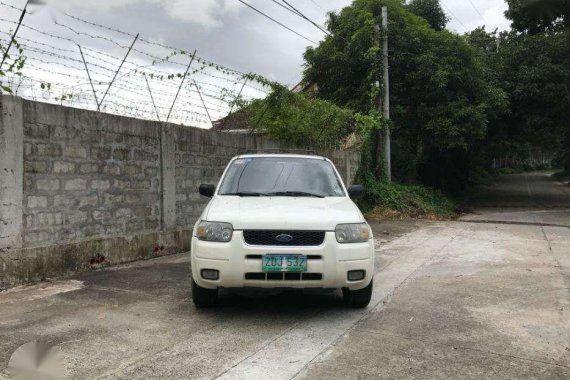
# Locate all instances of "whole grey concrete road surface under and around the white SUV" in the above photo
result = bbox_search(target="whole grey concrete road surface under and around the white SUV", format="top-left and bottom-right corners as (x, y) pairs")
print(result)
(0, 174), (570, 379)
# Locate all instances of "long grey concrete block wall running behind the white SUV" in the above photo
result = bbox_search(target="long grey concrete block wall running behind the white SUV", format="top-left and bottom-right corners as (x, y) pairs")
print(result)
(0, 96), (359, 289)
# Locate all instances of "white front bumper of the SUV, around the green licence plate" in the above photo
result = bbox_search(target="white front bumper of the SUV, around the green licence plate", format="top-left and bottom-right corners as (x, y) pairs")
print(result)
(191, 231), (374, 290)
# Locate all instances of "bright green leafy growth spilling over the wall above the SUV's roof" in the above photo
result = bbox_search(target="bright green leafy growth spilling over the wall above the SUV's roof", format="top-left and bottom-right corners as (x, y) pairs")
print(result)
(241, 84), (378, 146)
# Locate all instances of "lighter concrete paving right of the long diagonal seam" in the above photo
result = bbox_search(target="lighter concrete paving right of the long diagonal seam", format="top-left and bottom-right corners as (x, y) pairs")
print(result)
(300, 224), (570, 379)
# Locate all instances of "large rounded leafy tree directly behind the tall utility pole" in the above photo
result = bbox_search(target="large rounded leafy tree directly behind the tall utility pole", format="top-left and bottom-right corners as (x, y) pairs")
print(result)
(304, 0), (506, 190)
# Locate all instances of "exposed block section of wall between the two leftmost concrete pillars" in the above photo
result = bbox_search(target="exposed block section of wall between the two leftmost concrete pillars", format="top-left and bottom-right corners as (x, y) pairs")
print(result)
(22, 101), (161, 246)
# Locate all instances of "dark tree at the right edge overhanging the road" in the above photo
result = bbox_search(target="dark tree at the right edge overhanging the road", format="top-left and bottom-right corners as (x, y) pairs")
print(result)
(467, 0), (570, 168)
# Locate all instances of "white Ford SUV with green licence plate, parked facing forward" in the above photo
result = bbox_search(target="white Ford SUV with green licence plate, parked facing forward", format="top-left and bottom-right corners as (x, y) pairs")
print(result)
(191, 154), (374, 308)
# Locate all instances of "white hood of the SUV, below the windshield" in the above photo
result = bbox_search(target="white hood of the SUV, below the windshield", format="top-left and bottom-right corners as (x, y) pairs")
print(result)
(203, 196), (364, 231)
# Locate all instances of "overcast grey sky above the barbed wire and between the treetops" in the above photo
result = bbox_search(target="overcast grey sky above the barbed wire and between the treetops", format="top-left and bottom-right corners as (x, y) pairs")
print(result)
(4, 0), (509, 84)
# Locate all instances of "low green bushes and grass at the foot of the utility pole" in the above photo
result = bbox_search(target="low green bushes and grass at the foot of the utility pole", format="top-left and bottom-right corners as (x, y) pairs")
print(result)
(360, 181), (457, 220)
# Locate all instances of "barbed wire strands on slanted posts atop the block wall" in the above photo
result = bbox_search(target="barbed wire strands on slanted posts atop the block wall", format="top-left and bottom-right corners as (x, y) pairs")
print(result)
(0, 1), (270, 125)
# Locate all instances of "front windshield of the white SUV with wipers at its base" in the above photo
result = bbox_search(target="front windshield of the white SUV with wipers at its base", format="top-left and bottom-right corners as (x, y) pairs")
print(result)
(218, 157), (345, 197)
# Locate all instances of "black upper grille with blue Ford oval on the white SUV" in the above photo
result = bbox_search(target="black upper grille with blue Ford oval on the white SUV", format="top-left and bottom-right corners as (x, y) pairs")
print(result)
(243, 230), (325, 247)
